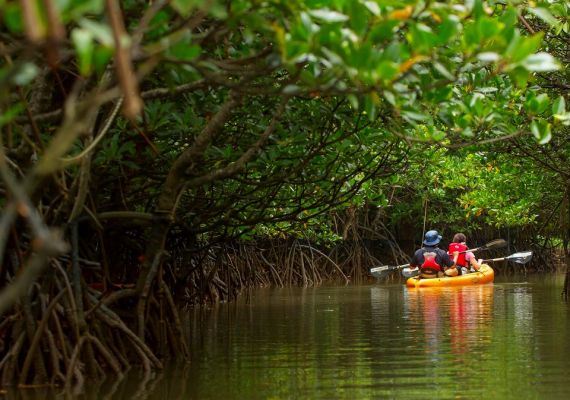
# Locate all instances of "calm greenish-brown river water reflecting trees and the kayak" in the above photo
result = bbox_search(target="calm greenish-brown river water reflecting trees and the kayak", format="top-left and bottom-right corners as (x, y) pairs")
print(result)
(6, 275), (570, 400)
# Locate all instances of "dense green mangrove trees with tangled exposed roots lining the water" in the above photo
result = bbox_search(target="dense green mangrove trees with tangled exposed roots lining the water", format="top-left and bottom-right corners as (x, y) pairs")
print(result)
(0, 0), (570, 388)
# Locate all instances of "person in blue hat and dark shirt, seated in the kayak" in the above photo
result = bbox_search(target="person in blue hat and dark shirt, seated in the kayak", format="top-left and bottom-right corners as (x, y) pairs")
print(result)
(410, 230), (459, 278)
